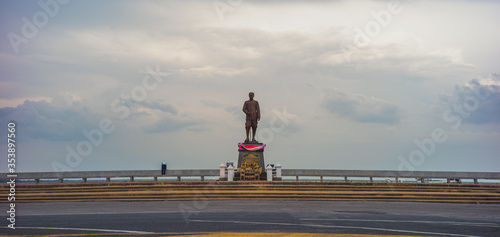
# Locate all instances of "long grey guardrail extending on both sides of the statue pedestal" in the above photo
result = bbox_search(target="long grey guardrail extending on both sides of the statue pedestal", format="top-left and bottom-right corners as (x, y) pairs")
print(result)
(0, 169), (500, 183)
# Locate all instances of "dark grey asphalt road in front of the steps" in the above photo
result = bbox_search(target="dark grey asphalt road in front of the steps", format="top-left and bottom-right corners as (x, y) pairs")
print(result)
(0, 199), (500, 236)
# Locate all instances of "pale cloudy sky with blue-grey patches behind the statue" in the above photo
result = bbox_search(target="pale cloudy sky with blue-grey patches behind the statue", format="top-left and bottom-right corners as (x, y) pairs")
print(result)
(0, 0), (500, 172)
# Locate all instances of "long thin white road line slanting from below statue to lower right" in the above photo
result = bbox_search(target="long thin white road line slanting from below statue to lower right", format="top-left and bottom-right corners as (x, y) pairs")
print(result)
(190, 220), (479, 237)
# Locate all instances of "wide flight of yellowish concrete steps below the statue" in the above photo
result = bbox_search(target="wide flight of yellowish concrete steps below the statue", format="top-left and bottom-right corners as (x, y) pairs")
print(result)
(0, 182), (500, 203)
